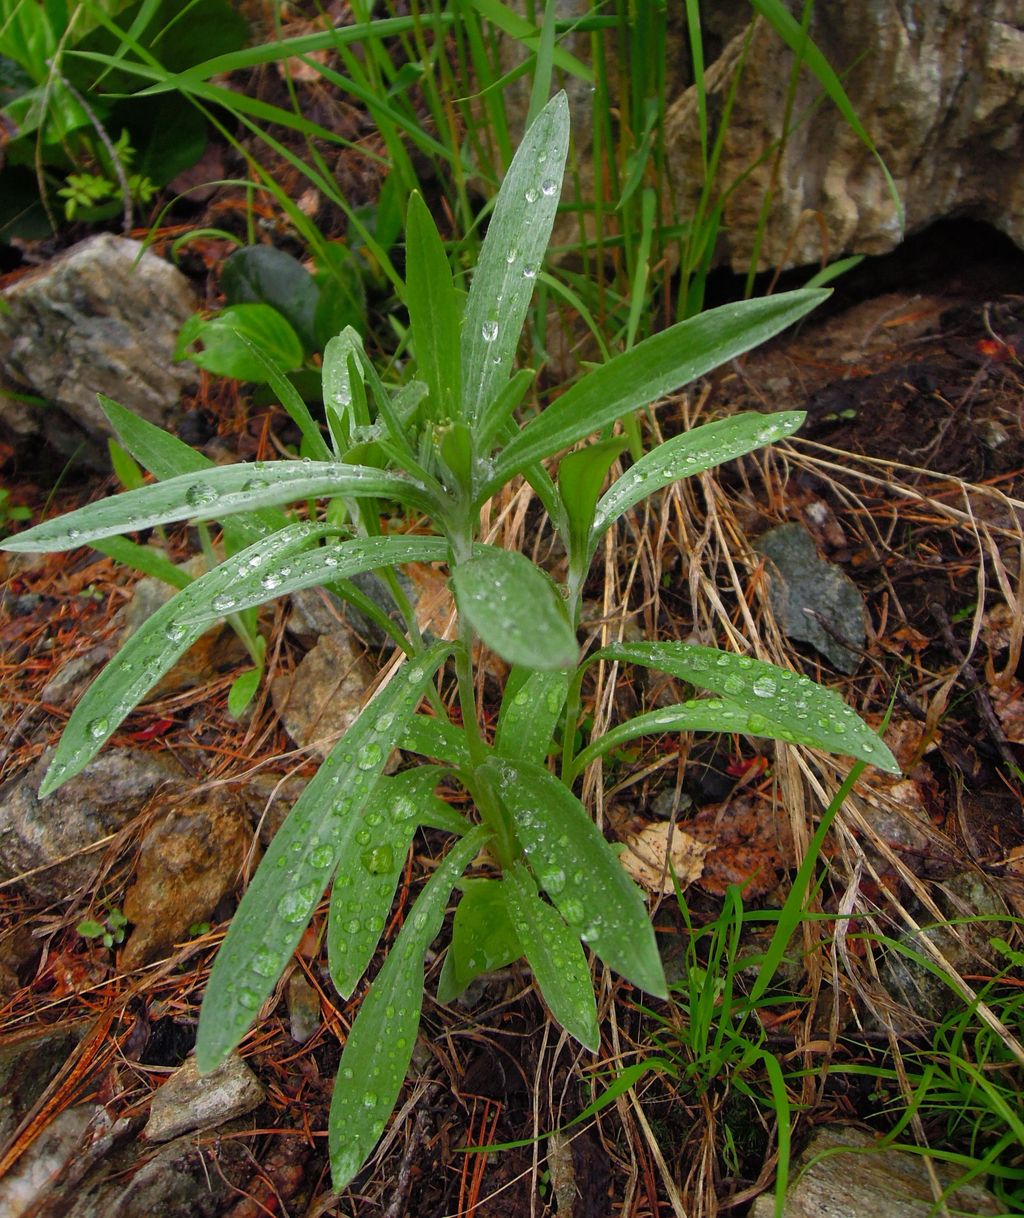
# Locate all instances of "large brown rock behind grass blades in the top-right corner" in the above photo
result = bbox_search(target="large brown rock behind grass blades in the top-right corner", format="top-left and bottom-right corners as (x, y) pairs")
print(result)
(664, 0), (1024, 272)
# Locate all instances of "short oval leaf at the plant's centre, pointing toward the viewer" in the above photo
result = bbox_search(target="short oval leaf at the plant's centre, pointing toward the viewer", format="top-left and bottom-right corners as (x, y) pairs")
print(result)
(450, 548), (580, 670)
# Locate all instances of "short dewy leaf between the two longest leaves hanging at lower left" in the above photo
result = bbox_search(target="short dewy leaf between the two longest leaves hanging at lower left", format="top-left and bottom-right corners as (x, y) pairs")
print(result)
(328, 766), (443, 998)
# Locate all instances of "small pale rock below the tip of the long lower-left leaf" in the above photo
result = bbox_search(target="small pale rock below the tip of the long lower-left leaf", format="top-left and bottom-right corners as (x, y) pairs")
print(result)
(142, 1054), (263, 1142)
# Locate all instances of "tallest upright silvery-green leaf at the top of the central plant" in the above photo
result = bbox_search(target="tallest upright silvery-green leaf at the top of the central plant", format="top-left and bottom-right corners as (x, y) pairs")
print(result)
(461, 93), (569, 429)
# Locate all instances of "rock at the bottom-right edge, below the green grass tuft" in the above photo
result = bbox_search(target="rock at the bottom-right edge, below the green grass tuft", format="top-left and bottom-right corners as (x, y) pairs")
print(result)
(750, 1125), (1002, 1218)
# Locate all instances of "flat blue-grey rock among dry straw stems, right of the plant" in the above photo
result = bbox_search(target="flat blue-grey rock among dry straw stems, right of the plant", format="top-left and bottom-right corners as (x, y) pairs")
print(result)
(756, 524), (866, 672)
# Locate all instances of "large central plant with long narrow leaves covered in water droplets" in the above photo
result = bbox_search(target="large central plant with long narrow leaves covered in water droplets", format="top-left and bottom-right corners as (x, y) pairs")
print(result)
(6, 94), (897, 1188)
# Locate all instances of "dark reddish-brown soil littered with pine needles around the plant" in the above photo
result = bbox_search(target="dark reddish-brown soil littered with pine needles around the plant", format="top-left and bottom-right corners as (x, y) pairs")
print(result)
(0, 190), (1024, 1218)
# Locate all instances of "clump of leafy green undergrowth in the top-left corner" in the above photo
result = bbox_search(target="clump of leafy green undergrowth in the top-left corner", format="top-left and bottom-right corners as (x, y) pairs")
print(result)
(0, 0), (248, 239)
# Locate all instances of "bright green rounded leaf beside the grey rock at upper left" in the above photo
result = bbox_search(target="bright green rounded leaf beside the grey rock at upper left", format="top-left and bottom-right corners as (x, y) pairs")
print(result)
(174, 305), (302, 381)
